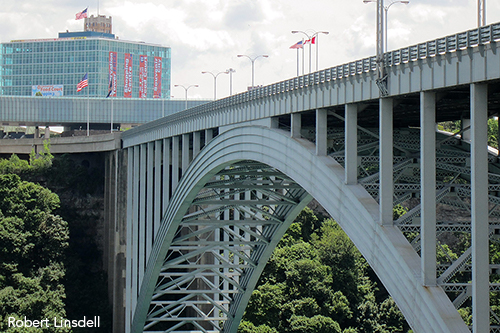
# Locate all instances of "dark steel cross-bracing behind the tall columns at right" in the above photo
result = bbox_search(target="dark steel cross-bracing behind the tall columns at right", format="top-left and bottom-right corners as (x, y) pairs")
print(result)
(330, 125), (500, 332)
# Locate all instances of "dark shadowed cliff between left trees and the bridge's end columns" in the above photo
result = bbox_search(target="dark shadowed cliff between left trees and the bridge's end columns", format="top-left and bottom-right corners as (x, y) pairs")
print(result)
(40, 154), (112, 332)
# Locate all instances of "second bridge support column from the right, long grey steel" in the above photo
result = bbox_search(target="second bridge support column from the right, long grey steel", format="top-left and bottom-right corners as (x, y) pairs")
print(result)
(420, 92), (436, 286)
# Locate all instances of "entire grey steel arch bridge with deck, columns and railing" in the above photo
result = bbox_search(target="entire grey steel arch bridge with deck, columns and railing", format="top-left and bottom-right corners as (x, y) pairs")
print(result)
(122, 24), (500, 333)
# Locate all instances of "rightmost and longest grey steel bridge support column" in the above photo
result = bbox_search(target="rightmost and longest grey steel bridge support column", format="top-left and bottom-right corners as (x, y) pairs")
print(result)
(470, 84), (490, 333)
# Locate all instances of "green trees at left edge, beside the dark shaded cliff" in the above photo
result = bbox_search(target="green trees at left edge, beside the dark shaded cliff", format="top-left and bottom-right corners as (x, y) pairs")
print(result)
(0, 174), (71, 332)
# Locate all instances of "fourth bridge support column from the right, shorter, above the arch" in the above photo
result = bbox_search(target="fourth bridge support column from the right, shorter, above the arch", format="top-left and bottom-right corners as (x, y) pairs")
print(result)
(344, 104), (358, 185)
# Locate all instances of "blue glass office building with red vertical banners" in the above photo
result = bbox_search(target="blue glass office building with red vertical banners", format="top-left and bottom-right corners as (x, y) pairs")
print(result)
(0, 31), (171, 99)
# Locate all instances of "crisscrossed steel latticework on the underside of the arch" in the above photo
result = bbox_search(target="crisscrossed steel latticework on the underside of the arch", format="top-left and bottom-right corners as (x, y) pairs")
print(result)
(144, 161), (309, 333)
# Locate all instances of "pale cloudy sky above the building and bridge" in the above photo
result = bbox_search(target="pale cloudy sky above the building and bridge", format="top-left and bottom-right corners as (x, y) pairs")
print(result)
(0, 0), (500, 99)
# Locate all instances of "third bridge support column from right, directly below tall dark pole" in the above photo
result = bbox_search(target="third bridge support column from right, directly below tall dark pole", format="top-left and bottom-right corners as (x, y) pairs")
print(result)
(379, 98), (394, 225)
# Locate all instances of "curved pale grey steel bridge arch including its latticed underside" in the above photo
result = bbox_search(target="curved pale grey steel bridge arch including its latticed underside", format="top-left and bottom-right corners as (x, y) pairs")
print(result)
(132, 126), (469, 333)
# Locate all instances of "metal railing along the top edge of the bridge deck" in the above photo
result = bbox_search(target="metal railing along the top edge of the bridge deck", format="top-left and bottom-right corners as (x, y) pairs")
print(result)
(124, 23), (500, 137)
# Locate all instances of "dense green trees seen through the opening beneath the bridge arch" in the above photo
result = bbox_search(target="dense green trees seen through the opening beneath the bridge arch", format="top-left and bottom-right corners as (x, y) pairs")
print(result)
(238, 207), (408, 333)
